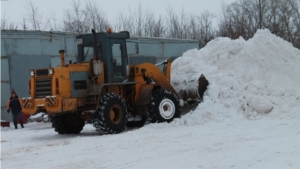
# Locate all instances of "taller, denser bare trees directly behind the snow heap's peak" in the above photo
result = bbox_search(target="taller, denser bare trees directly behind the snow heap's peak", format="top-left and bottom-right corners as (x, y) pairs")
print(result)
(218, 0), (300, 47)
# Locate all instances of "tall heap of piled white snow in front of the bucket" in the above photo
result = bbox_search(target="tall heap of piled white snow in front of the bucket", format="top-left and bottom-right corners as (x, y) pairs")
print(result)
(171, 30), (300, 125)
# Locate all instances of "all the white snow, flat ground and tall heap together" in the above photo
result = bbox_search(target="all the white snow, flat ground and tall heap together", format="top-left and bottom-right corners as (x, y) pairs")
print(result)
(1, 30), (300, 169)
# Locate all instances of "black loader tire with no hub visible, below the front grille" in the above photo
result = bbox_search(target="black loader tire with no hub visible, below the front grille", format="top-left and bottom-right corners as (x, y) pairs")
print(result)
(52, 113), (85, 134)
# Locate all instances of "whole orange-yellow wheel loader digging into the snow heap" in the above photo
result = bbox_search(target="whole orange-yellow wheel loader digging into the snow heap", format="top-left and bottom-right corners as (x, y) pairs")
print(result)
(22, 30), (208, 134)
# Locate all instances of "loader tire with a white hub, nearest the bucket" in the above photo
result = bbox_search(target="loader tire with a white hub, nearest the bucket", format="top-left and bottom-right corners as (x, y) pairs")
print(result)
(148, 89), (180, 123)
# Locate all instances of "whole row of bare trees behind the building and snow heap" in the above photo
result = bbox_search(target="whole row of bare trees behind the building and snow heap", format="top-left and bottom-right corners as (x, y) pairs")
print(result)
(1, 0), (300, 48)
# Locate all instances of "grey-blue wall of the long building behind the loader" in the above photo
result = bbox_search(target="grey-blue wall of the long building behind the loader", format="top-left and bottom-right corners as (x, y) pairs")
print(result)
(1, 30), (199, 121)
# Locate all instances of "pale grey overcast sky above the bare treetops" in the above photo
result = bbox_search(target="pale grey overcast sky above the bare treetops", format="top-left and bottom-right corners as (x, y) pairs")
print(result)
(1, 0), (235, 27)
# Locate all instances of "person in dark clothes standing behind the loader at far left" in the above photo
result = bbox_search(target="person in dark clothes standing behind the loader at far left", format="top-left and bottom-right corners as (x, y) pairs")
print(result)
(6, 92), (24, 129)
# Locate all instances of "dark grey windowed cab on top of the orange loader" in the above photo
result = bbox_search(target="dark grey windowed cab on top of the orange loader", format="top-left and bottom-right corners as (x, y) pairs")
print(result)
(76, 31), (129, 83)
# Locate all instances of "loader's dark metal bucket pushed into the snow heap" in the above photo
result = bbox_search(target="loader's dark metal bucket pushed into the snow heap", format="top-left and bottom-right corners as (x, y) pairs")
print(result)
(175, 74), (209, 106)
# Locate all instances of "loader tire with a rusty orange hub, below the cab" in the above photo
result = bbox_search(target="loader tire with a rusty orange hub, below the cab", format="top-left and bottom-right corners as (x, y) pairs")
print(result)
(93, 93), (127, 135)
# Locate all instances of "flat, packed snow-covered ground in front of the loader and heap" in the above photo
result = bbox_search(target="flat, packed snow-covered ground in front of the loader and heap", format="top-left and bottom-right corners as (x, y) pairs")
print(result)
(1, 118), (300, 169)
